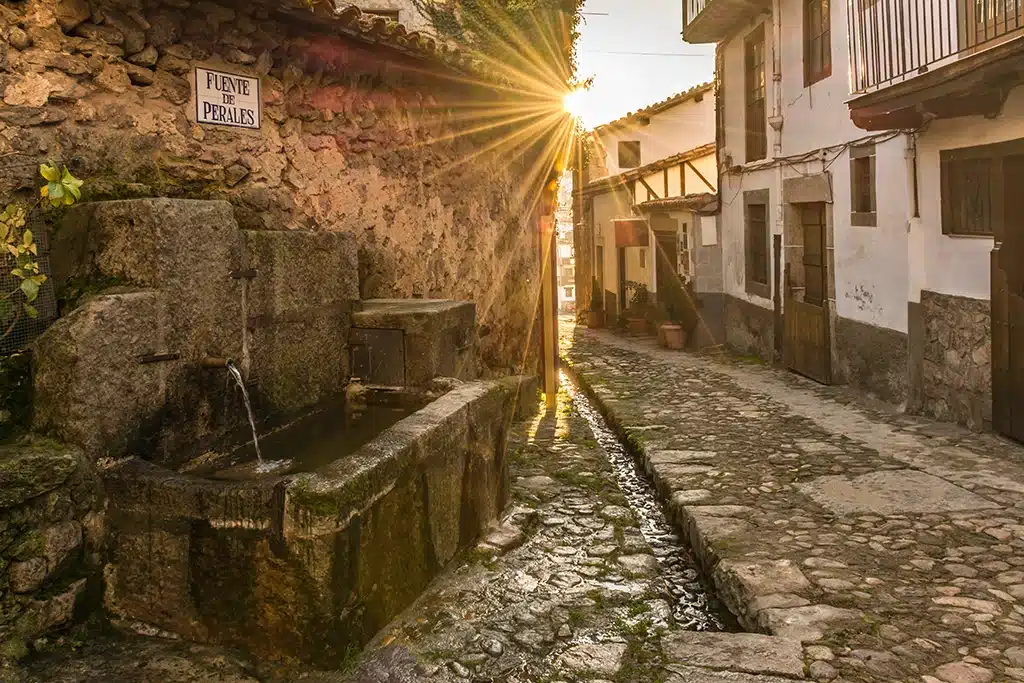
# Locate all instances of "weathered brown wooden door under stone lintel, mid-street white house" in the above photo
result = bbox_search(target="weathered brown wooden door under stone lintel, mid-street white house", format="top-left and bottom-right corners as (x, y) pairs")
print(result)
(782, 202), (831, 384)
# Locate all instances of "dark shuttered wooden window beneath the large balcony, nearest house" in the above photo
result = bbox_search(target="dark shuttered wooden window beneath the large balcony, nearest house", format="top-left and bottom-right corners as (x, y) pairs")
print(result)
(941, 157), (998, 236)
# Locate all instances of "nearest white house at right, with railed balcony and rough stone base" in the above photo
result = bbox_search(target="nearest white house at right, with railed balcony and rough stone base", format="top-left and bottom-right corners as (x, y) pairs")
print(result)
(847, 0), (1024, 440)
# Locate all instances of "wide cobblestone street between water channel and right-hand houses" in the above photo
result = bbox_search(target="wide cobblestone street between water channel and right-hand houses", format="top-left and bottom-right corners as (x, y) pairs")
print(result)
(562, 326), (1024, 683)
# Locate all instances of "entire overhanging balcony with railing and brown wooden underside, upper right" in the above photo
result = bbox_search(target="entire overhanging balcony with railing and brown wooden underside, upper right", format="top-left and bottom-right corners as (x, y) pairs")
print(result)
(847, 0), (1024, 130)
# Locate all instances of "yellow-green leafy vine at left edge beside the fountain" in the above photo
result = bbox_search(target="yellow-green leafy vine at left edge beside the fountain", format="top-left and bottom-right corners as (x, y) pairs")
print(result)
(0, 164), (82, 338)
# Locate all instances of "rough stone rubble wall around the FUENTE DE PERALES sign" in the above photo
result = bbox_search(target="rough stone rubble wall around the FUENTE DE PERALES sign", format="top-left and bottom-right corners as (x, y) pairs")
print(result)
(0, 0), (539, 374)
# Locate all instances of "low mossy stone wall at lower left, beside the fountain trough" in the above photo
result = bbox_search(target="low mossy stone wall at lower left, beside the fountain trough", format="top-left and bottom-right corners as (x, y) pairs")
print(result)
(0, 439), (103, 663)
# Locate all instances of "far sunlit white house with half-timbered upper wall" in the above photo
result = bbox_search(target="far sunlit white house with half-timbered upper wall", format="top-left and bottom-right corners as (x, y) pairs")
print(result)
(574, 84), (722, 342)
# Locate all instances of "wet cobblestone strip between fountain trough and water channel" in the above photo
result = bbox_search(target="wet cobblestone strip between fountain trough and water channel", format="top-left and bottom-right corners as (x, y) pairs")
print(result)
(339, 392), (716, 683)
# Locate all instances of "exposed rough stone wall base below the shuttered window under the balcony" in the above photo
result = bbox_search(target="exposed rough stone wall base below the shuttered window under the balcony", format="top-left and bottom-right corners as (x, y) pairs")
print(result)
(911, 291), (992, 430)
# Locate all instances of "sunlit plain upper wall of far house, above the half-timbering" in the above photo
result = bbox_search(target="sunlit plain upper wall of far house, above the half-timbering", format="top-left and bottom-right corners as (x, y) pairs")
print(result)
(591, 91), (715, 180)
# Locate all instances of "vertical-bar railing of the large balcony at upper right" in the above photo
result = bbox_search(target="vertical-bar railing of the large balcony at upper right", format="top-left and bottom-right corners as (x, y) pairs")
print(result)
(847, 0), (1024, 93)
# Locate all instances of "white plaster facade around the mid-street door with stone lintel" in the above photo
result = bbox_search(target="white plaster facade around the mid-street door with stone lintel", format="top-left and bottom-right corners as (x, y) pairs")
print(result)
(716, 0), (910, 332)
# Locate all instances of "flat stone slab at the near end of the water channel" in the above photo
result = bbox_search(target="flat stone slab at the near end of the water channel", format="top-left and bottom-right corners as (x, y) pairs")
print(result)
(662, 632), (804, 678)
